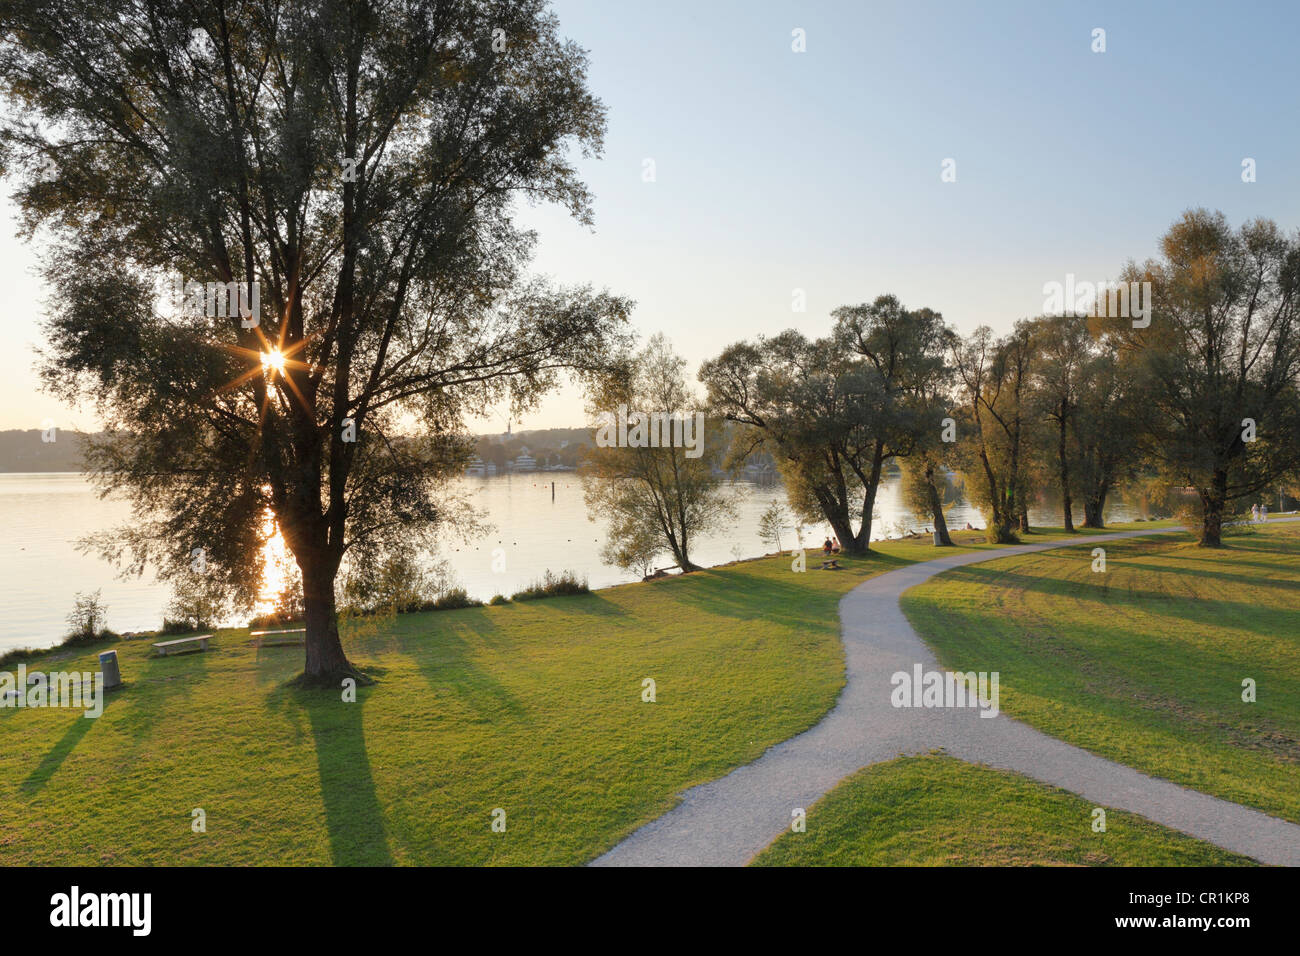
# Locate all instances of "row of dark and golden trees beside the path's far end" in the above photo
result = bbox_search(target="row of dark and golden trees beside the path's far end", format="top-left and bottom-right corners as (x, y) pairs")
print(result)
(699, 209), (1300, 554)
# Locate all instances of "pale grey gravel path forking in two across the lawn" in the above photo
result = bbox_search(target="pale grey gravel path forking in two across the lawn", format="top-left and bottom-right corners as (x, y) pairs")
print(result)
(593, 529), (1300, 866)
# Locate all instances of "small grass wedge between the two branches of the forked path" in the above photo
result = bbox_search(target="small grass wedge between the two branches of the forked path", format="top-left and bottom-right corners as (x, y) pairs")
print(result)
(753, 753), (1255, 866)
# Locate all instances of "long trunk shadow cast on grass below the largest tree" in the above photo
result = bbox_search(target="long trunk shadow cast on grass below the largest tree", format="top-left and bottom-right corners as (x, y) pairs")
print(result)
(276, 687), (393, 866)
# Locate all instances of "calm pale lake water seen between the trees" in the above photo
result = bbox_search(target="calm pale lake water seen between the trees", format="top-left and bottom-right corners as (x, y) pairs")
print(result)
(0, 472), (1132, 652)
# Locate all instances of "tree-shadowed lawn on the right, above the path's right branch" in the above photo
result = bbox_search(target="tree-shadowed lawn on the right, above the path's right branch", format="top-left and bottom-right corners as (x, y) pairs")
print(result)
(902, 524), (1300, 822)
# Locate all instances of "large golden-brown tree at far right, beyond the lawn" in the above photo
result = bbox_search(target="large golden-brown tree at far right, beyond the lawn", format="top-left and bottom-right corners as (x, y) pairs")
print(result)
(1109, 209), (1300, 548)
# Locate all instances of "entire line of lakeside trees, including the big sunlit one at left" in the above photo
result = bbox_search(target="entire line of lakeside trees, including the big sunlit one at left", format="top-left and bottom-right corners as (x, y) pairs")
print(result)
(0, 0), (1300, 687)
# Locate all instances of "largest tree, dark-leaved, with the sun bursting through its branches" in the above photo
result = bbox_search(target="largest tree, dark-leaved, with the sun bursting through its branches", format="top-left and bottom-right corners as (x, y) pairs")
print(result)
(0, 0), (629, 683)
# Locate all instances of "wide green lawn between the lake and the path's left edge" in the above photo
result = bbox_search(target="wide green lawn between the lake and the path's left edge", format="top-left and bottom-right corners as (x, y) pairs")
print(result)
(0, 525), (1206, 865)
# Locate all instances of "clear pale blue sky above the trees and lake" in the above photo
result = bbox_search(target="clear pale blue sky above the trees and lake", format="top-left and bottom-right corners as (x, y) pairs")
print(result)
(0, 0), (1300, 431)
